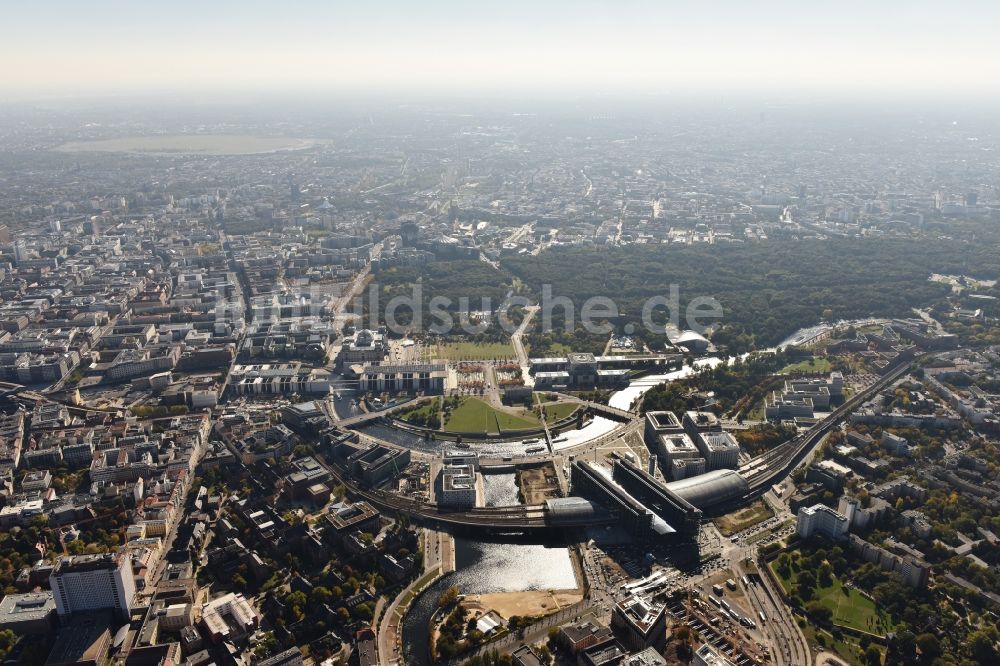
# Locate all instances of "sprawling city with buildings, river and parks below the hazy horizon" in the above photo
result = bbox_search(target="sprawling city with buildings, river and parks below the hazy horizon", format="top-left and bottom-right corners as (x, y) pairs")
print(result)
(0, 1), (1000, 666)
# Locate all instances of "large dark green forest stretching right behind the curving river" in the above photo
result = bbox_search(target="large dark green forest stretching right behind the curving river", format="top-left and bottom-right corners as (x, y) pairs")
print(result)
(505, 238), (1000, 352)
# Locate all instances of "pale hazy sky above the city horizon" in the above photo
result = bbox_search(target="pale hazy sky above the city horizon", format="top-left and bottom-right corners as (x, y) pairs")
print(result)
(7, 0), (1000, 98)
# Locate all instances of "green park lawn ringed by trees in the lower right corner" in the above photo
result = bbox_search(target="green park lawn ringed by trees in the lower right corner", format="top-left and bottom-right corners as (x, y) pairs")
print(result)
(770, 553), (893, 636)
